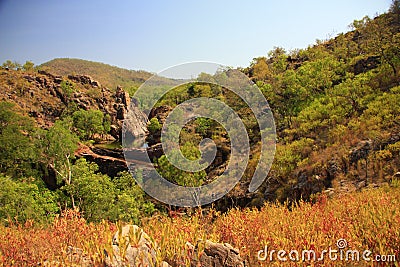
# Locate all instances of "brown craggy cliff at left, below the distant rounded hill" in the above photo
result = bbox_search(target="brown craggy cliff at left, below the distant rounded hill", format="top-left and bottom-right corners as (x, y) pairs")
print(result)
(0, 69), (147, 141)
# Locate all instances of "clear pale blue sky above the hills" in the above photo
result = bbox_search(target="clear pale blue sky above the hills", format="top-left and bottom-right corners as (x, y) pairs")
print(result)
(0, 0), (391, 72)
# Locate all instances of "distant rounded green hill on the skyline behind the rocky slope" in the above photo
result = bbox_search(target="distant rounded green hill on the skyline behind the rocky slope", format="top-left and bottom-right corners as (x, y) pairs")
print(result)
(40, 58), (152, 91)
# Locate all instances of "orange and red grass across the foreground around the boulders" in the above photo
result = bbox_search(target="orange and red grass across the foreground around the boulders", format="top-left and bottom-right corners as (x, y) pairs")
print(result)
(0, 186), (400, 266)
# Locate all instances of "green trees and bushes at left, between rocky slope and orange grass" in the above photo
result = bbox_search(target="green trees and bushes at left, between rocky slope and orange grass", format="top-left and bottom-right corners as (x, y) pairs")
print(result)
(0, 102), (154, 223)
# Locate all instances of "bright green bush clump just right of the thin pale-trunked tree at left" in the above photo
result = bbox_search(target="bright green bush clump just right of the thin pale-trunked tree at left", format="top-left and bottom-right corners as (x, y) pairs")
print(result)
(61, 158), (155, 223)
